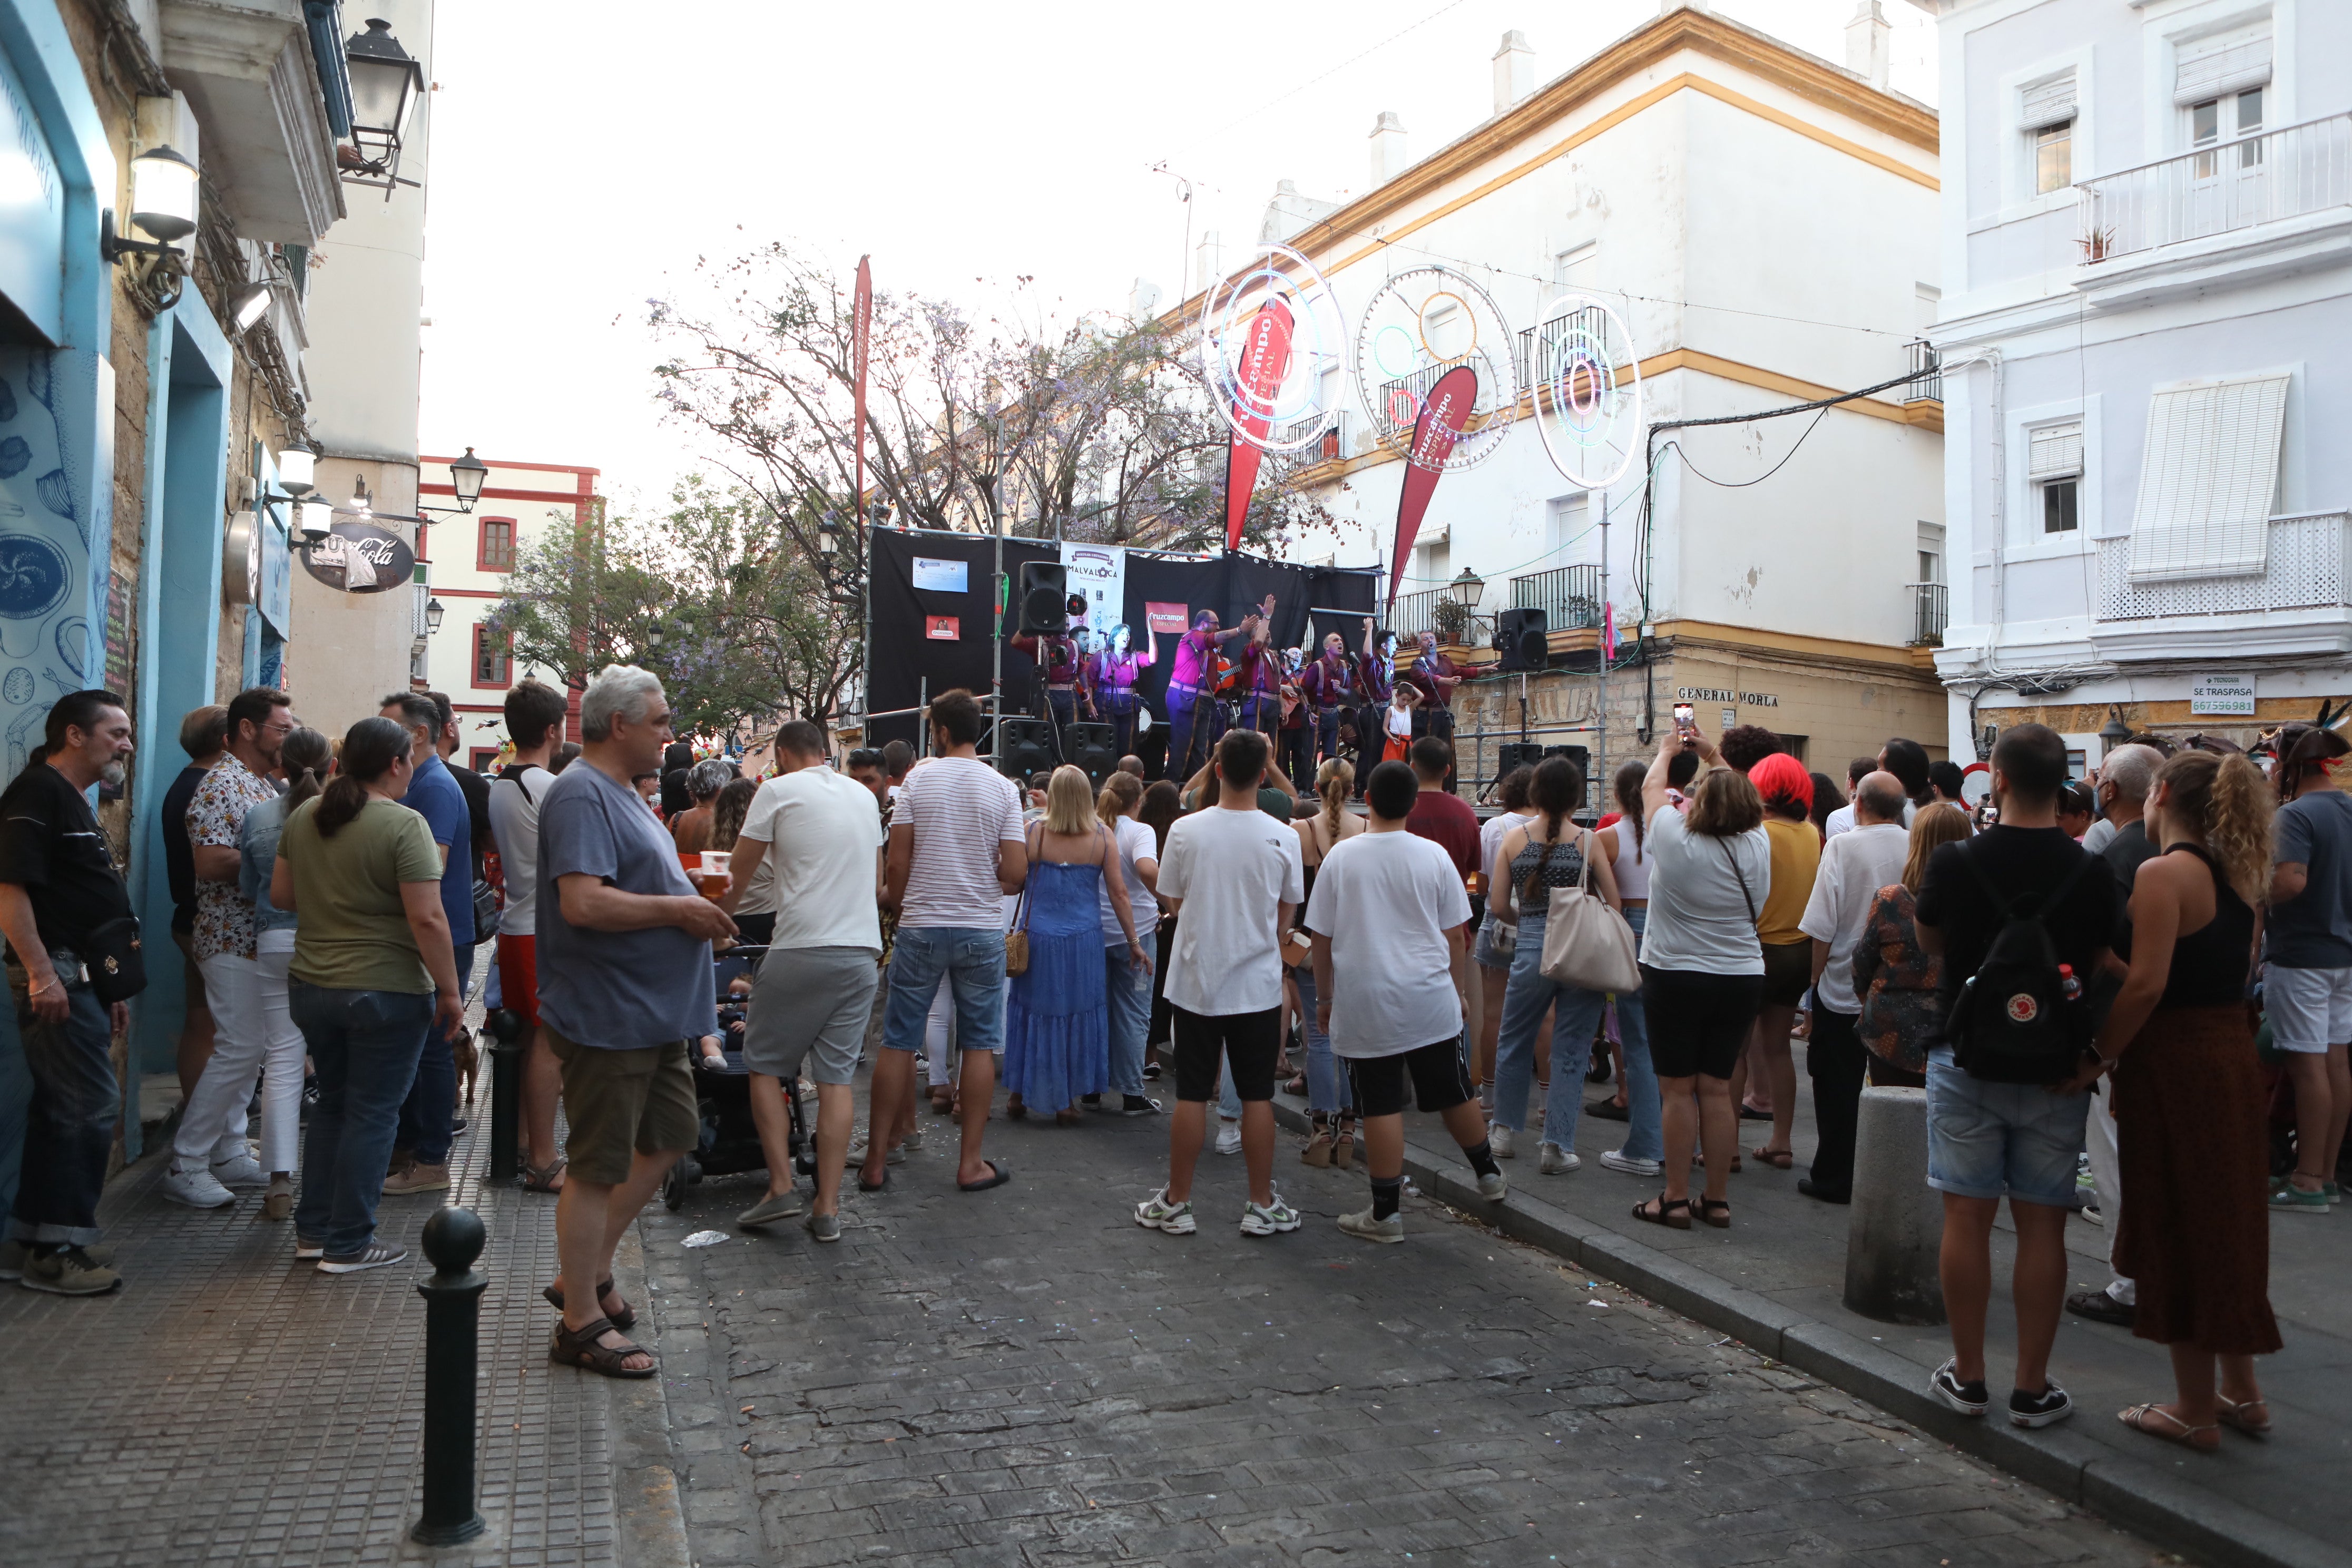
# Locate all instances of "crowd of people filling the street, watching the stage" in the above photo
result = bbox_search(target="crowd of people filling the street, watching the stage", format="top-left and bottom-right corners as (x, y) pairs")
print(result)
(0, 663), (2352, 1448)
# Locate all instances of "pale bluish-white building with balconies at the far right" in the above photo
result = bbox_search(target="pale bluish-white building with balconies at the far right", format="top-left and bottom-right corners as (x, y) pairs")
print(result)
(1915, 0), (2352, 764)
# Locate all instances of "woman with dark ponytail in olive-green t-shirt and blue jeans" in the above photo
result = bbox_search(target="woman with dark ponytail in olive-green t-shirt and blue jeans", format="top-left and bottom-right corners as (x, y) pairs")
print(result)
(270, 717), (466, 1274)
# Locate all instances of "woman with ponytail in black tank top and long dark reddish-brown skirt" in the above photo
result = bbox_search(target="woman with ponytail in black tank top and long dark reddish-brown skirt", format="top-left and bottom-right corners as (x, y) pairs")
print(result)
(2074, 752), (2279, 1453)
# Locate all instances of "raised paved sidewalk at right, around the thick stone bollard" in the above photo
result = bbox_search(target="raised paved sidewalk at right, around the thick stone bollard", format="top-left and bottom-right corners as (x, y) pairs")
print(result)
(1326, 1042), (2352, 1568)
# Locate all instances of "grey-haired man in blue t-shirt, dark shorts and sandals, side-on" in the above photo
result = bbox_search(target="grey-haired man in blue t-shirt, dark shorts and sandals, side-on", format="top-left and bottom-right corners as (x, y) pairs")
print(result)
(536, 665), (736, 1378)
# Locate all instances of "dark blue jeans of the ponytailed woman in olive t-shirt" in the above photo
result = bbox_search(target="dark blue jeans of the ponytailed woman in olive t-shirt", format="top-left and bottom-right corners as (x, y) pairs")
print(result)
(287, 981), (435, 1258)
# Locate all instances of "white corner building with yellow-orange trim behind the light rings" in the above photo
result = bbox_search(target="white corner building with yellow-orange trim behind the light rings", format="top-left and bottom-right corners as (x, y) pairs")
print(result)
(1185, 7), (1945, 773)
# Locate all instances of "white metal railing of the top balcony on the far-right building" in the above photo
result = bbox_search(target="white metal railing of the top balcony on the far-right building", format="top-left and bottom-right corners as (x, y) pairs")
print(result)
(2077, 113), (2352, 263)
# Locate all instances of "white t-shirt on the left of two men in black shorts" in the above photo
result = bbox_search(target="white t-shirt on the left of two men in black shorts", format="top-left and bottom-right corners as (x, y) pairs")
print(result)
(1160, 806), (1307, 1020)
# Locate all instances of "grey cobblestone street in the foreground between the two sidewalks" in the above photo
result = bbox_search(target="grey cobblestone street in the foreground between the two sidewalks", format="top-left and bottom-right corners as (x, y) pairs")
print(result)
(642, 1091), (2171, 1568)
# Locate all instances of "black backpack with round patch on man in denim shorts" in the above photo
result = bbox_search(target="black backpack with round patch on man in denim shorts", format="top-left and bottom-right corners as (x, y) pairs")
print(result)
(1945, 849), (2108, 1084)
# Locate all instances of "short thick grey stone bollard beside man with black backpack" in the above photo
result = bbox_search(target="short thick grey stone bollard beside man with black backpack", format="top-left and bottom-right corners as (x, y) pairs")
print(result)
(1846, 1089), (1947, 1324)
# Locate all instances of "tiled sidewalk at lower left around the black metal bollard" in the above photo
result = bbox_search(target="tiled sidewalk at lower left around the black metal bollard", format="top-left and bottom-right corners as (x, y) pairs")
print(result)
(0, 1063), (682, 1568)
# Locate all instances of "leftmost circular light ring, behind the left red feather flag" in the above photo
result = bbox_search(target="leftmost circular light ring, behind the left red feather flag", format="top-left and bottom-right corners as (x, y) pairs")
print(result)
(1200, 244), (1348, 452)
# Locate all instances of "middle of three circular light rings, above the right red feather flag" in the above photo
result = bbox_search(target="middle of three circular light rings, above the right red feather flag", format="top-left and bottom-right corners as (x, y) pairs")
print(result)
(1355, 263), (1520, 473)
